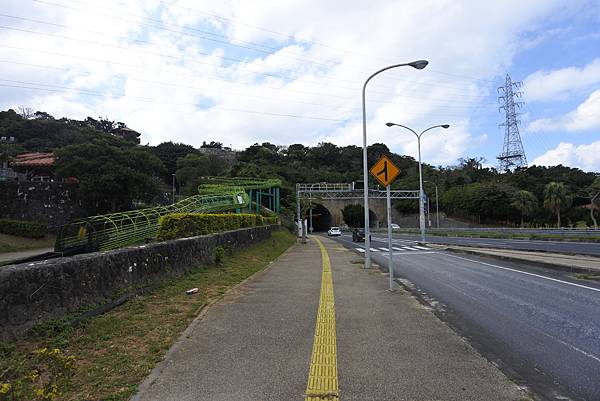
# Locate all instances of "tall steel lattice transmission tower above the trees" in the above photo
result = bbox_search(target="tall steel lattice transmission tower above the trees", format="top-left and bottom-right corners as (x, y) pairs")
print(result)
(498, 74), (527, 171)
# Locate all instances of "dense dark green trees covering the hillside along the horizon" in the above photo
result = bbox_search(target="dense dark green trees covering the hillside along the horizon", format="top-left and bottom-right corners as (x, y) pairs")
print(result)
(0, 110), (600, 227)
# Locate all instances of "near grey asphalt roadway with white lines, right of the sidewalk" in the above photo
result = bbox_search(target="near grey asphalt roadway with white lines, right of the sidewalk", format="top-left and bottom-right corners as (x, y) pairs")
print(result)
(330, 236), (600, 401)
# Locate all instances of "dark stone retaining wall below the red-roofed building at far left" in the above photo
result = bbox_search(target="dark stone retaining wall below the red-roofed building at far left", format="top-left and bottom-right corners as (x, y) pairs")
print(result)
(0, 181), (87, 232)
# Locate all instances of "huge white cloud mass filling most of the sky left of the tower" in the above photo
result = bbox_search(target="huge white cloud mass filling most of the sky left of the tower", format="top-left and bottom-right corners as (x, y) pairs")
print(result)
(0, 0), (582, 164)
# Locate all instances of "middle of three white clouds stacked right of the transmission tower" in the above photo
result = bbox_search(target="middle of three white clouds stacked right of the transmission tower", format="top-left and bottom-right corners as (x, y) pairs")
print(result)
(527, 89), (600, 132)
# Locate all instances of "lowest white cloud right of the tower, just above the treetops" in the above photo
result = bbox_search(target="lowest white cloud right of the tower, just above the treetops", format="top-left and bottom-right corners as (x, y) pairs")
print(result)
(531, 141), (600, 172)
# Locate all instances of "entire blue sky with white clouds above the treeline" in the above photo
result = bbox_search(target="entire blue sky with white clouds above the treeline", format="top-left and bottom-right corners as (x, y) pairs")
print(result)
(0, 0), (600, 172)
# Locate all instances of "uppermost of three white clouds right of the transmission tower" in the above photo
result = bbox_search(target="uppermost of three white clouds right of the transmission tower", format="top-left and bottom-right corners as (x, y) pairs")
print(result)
(523, 58), (600, 102)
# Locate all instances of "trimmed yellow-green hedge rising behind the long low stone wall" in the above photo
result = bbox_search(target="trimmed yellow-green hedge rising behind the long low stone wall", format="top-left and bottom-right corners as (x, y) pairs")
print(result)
(157, 213), (277, 241)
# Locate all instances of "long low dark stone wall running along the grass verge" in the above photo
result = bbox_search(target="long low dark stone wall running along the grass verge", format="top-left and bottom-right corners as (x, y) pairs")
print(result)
(0, 226), (278, 340)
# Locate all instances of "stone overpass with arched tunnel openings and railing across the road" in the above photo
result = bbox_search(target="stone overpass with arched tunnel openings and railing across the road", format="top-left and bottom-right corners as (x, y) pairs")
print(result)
(296, 182), (419, 231)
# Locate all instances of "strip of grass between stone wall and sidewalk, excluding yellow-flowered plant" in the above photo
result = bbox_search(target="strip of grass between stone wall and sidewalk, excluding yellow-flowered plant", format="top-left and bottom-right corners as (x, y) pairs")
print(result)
(0, 231), (296, 401)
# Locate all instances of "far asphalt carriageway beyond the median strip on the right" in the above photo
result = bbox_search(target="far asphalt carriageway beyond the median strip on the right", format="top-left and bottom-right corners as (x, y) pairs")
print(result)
(390, 233), (600, 256)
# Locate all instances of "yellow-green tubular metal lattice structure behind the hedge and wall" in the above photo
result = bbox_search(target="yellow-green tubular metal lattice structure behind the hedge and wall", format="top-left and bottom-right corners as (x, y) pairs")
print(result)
(54, 177), (281, 254)
